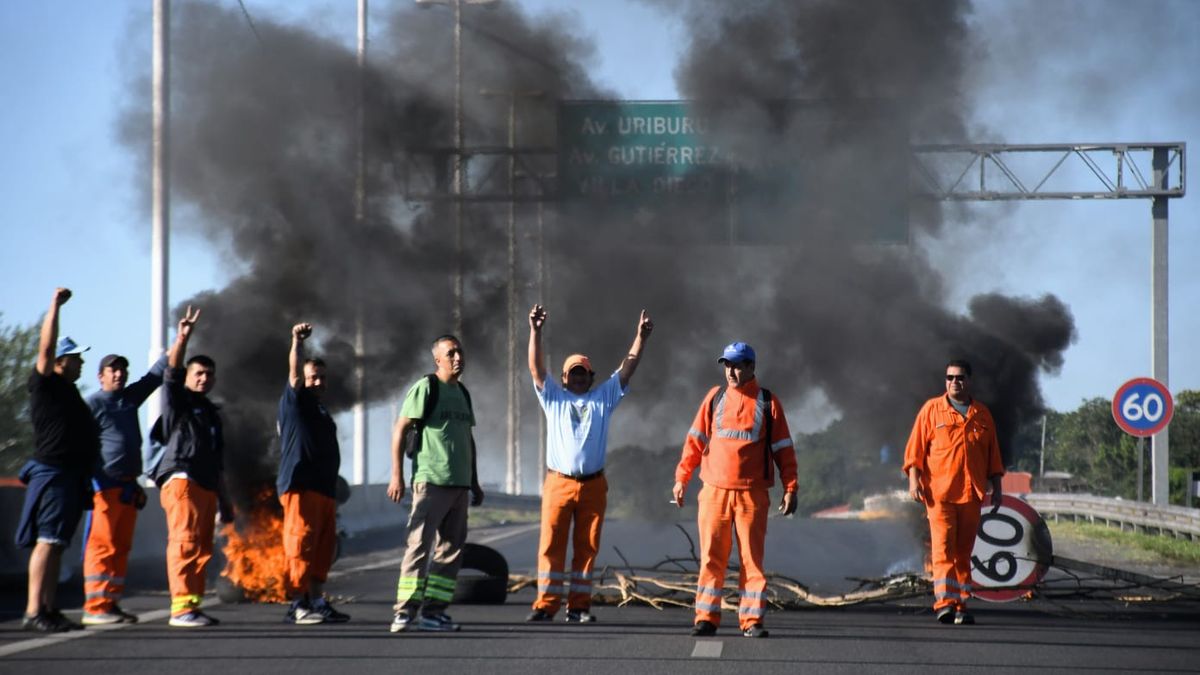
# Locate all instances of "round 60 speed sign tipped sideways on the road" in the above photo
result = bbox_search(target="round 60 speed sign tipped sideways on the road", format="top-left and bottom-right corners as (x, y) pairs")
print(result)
(971, 495), (1054, 602)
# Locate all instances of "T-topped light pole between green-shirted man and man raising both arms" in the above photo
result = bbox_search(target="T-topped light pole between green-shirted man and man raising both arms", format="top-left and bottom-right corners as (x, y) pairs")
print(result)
(479, 89), (544, 495)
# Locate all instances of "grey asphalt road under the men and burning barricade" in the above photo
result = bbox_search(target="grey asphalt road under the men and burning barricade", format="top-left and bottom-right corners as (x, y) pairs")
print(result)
(0, 519), (1200, 675)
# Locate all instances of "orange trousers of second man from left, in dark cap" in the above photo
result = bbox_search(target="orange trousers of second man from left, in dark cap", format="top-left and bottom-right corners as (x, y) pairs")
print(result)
(83, 488), (138, 614)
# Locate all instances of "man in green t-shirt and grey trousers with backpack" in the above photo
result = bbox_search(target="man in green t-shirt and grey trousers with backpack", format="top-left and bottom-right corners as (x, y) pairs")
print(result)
(388, 335), (484, 633)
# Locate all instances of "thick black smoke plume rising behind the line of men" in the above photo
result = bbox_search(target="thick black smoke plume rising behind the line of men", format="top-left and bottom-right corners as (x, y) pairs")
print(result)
(122, 0), (1073, 506)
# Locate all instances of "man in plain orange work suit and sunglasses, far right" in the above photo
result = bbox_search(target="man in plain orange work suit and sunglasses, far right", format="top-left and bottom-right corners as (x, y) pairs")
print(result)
(904, 360), (1004, 625)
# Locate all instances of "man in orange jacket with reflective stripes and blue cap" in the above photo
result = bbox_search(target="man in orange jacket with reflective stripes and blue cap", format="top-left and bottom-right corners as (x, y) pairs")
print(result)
(672, 342), (796, 638)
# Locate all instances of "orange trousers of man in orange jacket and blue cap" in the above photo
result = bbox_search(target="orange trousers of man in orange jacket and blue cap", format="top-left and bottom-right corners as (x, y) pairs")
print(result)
(696, 485), (770, 629)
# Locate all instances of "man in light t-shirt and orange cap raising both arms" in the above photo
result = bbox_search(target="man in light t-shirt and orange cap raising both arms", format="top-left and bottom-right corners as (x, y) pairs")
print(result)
(526, 305), (654, 623)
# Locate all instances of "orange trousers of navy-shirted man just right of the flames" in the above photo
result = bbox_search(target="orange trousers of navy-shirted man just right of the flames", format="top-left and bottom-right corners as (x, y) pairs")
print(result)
(280, 490), (337, 597)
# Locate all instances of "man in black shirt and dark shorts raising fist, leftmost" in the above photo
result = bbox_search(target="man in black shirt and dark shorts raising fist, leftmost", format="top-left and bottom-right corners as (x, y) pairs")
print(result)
(16, 288), (100, 633)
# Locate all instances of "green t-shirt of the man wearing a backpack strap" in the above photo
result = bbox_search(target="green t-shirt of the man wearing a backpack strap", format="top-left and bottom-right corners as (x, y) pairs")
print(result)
(400, 377), (475, 488)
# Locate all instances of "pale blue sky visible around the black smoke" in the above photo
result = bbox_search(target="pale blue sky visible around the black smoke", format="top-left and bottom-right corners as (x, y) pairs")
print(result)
(0, 0), (1200, 476)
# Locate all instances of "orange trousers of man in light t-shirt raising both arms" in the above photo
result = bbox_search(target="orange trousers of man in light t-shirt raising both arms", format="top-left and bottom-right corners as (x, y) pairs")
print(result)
(533, 471), (608, 615)
